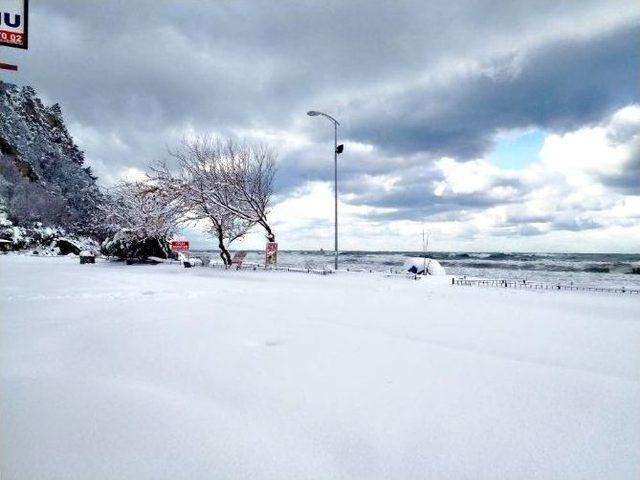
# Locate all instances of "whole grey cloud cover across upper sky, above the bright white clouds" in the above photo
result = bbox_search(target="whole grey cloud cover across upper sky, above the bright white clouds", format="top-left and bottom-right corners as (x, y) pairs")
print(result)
(1, 0), (640, 197)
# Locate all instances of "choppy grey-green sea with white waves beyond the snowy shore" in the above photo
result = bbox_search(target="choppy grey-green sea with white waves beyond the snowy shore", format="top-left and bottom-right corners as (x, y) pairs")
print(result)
(193, 250), (640, 288)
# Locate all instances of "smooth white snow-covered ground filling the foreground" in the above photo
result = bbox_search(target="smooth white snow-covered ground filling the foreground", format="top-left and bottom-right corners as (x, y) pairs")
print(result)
(0, 256), (640, 480)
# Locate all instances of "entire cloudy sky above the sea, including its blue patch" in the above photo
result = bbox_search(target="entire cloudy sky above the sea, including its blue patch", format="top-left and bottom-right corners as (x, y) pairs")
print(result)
(0, 0), (640, 252)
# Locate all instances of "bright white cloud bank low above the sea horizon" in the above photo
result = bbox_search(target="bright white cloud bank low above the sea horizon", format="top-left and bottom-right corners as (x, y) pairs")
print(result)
(273, 105), (640, 252)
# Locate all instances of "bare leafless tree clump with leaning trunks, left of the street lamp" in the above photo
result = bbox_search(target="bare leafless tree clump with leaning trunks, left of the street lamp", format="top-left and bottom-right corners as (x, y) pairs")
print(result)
(151, 136), (276, 265)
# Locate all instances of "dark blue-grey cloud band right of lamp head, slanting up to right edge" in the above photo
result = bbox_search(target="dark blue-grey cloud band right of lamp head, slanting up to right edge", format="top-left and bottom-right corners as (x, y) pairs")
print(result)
(352, 26), (640, 158)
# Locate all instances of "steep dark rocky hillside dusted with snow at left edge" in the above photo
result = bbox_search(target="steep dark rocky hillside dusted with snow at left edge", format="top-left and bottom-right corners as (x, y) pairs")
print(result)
(0, 81), (101, 234)
